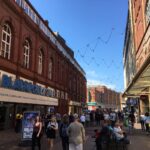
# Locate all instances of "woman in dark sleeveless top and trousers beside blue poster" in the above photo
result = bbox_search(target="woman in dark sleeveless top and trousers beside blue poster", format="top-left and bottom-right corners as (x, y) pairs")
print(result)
(32, 116), (42, 150)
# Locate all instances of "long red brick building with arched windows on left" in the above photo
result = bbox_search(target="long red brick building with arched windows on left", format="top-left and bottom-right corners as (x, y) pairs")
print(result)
(0, 0), (86, 129)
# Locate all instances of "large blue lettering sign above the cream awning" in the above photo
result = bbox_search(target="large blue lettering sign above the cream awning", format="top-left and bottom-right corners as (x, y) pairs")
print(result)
(1, 75), (53, 97)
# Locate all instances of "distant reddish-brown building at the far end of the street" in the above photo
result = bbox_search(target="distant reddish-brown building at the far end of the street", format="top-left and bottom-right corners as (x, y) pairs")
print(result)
(87, 86), (122, 110)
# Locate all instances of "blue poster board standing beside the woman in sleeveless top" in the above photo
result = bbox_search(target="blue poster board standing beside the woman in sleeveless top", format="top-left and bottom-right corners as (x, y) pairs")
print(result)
(22, 111), (40, 141)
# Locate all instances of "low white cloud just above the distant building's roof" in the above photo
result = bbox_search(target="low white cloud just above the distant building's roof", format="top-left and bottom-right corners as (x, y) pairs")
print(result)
(87, 79), (116, 90)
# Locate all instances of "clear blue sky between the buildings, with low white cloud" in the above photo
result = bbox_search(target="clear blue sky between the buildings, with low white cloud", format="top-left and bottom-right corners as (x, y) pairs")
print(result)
(30, 0), (128, 91)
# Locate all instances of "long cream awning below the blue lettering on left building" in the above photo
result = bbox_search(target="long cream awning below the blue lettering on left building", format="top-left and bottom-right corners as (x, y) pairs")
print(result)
(0, 88), (58, 106)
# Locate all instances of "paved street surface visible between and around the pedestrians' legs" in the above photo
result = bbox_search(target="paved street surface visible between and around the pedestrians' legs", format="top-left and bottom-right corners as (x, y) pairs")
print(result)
(0, 125), (150, 150)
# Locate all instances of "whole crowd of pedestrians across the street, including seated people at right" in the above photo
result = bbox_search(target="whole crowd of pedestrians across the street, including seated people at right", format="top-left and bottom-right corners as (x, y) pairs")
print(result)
(13, 108), (150, 150)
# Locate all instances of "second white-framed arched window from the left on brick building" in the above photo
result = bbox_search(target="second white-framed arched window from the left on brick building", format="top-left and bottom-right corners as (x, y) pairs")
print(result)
(23, 40), (31, 69)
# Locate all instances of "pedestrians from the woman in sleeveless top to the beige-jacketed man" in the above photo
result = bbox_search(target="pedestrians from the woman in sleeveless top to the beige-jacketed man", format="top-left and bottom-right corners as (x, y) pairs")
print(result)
(32, 113), (85, 150)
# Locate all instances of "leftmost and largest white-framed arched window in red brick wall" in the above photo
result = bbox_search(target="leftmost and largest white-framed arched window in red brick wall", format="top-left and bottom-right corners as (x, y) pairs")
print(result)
(0, 23), (12, 59)
